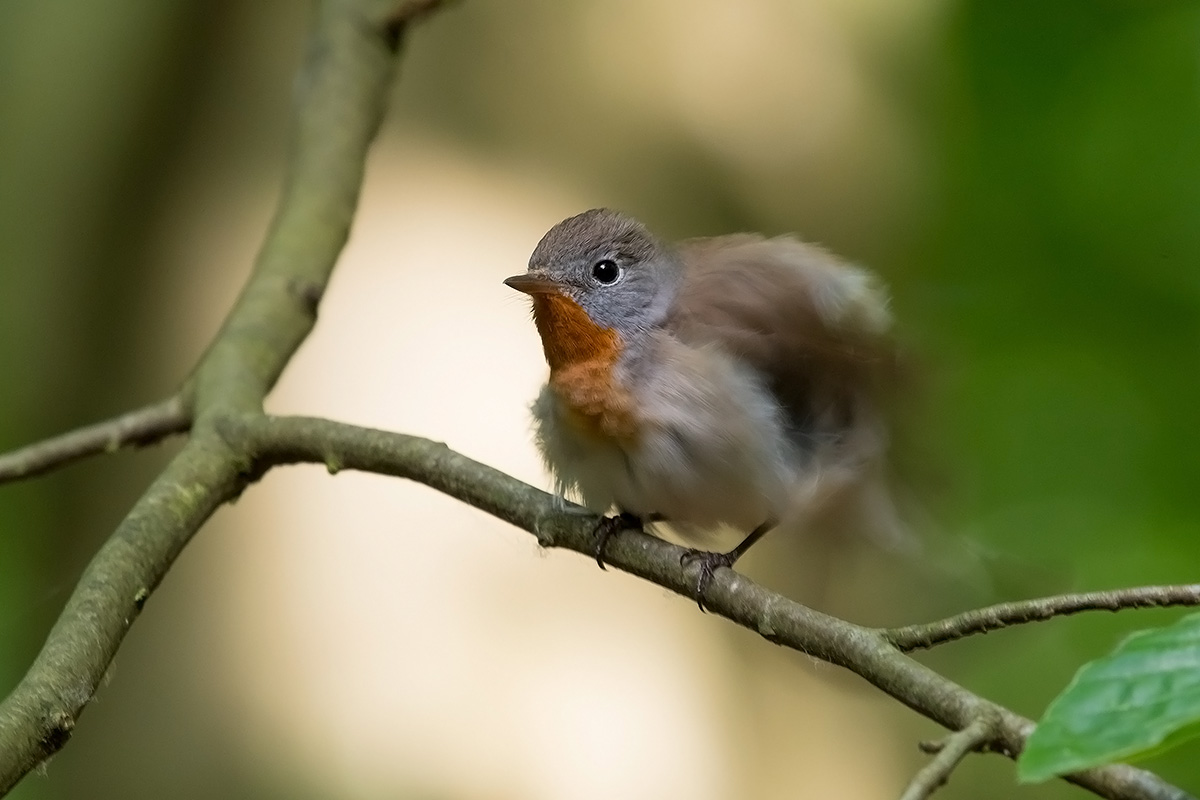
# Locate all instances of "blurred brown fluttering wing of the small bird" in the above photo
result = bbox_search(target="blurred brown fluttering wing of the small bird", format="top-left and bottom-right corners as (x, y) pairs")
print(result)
(667, 234), (896, 450)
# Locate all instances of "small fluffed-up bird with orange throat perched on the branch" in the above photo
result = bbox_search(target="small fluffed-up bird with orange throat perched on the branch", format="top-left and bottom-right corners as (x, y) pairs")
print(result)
(505, 209), (896, 608)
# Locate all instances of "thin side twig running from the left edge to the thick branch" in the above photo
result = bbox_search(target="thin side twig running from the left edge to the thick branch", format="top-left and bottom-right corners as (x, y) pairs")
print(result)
(0, 393), (192, 483)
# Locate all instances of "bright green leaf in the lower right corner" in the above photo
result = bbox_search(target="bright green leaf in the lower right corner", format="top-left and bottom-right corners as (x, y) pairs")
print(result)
(1016, 614), (1200, 783)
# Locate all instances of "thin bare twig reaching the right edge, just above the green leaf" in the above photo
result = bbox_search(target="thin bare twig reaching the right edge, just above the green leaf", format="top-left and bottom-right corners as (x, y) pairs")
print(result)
(882, 583), (1200, 652)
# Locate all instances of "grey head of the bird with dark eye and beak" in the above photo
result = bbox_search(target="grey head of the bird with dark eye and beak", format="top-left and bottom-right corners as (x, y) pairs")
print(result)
(505, 209), (682, 338)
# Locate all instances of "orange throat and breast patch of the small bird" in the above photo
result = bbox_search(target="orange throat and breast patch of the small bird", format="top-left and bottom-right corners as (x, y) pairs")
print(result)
(533, 294), (636, 439)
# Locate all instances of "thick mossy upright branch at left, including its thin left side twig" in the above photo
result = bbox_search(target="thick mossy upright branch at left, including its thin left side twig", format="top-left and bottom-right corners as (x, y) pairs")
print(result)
(0, 0), (439, 794)
